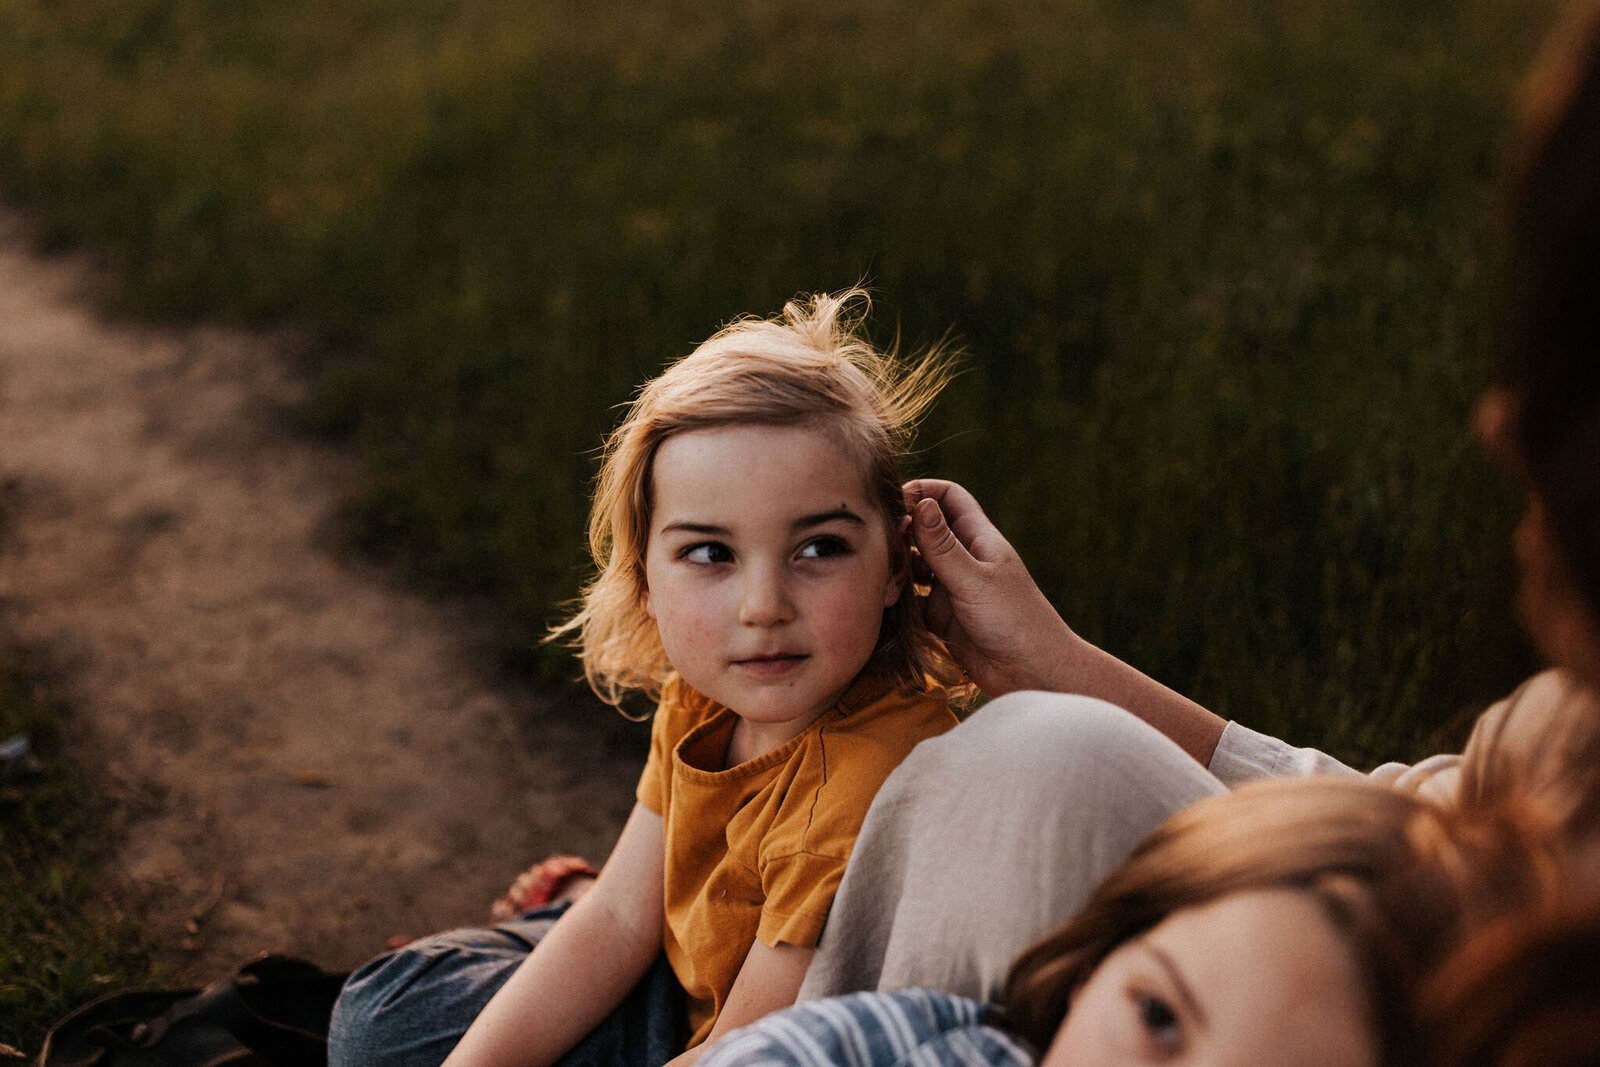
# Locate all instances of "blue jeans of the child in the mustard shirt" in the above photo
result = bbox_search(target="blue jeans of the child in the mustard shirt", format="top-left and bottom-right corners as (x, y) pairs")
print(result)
(328, 904), (688, 1067)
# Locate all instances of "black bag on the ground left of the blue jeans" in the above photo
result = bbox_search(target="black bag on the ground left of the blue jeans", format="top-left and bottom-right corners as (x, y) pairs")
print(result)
(35, 955), (346, 1067)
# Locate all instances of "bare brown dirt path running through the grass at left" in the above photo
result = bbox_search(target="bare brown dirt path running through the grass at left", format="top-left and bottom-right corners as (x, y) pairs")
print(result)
(0, 213), (637, 977)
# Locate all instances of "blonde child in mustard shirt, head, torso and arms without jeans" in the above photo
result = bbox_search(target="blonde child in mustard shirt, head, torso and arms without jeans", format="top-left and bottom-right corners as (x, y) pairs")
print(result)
(446, 291), (960, 1067)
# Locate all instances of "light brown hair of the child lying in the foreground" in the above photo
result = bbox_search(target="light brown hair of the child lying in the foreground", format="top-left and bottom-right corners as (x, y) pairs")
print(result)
(1005, 777), (1557, 1064)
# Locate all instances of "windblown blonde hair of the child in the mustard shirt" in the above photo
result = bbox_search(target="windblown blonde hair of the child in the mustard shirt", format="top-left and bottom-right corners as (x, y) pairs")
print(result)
(552, 290), (970, 704)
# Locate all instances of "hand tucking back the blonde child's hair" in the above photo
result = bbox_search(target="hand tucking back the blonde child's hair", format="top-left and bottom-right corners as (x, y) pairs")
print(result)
(906, 478), (1078, 696)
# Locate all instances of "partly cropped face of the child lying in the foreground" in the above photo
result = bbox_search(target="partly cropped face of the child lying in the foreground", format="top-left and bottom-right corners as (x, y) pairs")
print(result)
(1042, 889), (1378, 1067)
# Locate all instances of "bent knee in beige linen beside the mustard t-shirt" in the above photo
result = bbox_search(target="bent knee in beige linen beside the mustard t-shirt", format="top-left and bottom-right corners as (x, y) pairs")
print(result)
(800, 693), (1227, 1000)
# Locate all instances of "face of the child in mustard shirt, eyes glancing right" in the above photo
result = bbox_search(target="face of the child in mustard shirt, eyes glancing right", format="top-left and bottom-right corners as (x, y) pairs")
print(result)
(645, 426), (906, 752)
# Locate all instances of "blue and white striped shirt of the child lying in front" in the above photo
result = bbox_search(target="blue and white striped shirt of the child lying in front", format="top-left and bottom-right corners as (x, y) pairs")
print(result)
(698, 989), (1034, 1067)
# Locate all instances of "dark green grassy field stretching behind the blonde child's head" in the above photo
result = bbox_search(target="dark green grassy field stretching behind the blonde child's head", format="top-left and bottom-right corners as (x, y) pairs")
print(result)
(0, 0), (1550, 771)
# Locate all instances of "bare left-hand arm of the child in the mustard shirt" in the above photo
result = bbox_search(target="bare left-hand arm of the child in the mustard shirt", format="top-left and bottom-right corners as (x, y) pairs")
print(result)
(445, 805), (665, 1067)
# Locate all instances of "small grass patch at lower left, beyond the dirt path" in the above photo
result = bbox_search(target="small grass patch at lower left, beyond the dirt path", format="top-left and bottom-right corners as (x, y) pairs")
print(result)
(0, 654), (152, 1053)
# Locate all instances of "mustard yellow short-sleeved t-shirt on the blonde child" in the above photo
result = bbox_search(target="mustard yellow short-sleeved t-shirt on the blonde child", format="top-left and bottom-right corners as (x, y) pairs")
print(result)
(638, 673), (955, 1046)
